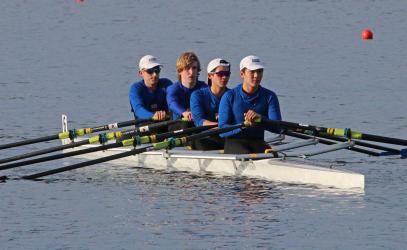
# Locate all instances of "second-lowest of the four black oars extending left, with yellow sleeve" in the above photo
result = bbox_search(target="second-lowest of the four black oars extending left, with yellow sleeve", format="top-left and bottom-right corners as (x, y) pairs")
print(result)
(0, 125), (215, 170)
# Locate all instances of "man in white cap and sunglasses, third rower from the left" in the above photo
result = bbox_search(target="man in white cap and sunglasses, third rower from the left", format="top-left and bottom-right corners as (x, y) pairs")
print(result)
(191, 58), (230, 150)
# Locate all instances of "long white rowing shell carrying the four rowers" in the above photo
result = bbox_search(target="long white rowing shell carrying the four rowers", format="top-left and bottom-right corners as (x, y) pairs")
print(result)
(63, 115), (365, 190)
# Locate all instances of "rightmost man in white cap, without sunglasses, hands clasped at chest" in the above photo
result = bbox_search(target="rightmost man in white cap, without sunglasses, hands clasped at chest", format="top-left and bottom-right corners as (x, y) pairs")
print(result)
(219, 56), (281, 154)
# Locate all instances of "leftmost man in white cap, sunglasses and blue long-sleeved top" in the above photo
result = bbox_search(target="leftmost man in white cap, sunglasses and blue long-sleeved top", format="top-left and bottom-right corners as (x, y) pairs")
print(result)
(129, 55), (172, 120)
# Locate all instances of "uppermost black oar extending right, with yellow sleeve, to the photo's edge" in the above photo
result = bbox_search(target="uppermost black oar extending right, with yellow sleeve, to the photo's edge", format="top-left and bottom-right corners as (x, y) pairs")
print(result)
(261, 118), (407, 146)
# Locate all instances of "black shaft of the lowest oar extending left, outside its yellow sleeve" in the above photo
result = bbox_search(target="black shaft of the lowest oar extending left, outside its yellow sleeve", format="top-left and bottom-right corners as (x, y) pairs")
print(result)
(22, 146), (151, 180)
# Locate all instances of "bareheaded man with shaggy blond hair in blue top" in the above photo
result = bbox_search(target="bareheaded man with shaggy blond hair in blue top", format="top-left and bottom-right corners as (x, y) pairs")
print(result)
(167, 52), (207, 129)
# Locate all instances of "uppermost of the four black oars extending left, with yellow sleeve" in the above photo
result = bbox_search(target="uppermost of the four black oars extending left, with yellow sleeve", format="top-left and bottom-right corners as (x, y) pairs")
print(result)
(0, 119), (153, 150)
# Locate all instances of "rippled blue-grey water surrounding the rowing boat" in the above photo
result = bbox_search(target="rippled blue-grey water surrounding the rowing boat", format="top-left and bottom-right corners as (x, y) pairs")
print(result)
(0, 0), (407, 249)
